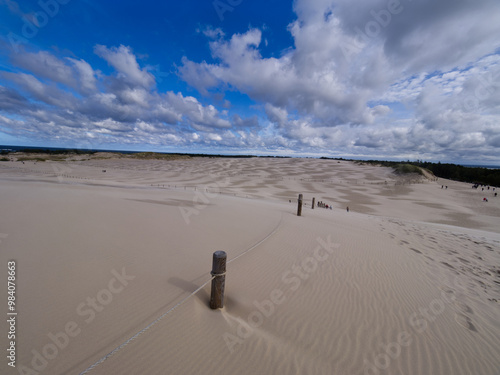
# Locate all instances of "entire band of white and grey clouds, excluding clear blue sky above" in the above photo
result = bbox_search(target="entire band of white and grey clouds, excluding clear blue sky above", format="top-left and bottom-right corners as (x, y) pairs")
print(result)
(0, 0), (500, 161)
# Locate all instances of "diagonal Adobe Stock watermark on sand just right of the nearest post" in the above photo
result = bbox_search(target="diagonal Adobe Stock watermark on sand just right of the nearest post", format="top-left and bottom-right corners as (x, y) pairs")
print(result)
(222, 235), (340, 354)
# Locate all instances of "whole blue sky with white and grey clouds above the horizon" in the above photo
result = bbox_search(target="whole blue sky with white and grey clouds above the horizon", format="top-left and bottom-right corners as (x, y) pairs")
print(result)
(0, 0), (500, 165)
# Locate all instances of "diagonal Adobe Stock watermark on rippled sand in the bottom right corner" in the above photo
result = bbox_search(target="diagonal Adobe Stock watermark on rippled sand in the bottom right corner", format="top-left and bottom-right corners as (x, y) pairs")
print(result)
(363, 277), (464, 375)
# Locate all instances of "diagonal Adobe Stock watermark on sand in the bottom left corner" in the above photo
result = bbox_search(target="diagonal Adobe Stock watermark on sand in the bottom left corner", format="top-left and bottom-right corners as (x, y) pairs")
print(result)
(18, 267), (135, 375)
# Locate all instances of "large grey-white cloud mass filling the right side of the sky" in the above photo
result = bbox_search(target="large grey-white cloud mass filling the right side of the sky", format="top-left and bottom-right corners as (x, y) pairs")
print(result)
(179, 0), (500, 159)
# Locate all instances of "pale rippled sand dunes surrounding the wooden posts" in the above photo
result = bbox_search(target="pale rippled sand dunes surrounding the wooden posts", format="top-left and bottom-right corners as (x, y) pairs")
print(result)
(0, 158), (500, 375)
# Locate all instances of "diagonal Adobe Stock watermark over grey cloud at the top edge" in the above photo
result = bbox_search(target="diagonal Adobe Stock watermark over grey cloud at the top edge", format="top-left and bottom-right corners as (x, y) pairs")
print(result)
(340, 0), (412, 60)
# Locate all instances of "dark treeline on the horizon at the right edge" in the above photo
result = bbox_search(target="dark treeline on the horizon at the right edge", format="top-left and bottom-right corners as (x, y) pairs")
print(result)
(322, 158), (500, 186)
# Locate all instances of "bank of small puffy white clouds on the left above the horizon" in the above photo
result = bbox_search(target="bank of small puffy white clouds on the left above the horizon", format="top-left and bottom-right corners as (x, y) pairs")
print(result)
(0, 42), (264, 147)
